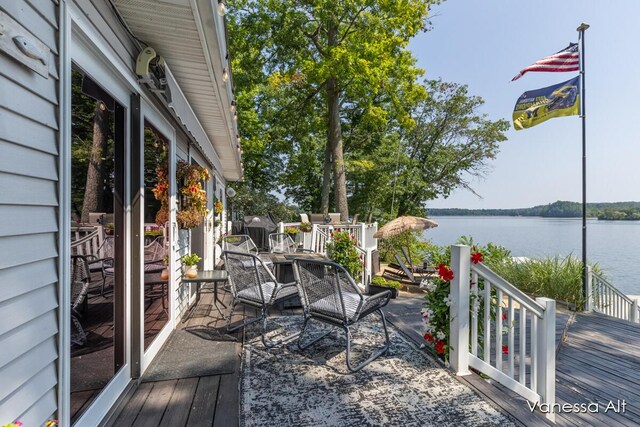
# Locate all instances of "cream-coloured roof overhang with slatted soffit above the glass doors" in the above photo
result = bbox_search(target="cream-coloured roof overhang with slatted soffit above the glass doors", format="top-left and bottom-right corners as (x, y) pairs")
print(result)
(113, 0), (242, 181)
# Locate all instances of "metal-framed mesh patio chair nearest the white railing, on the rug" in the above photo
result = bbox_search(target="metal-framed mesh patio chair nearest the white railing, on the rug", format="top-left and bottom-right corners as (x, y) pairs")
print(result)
(293, 259), (391, 372)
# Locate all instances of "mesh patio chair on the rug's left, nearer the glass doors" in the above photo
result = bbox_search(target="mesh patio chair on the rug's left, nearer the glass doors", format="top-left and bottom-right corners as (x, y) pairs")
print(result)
(222, 251), (298, 348)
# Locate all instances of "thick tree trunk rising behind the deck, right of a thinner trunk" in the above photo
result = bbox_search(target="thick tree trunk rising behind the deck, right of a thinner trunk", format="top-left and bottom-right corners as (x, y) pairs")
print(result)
(327, 20), (349, 221)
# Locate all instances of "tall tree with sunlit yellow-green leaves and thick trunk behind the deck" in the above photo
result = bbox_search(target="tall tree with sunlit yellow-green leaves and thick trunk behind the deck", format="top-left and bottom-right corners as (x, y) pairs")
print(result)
(230, 0), (431, 219)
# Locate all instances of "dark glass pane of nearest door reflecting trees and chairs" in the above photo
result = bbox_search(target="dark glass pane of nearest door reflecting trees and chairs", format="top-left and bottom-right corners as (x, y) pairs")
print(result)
(69, 67), (126, 422)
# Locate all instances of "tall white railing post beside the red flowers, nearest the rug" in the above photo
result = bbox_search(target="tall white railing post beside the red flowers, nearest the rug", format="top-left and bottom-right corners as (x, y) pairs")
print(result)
(449, 245), (471, 375)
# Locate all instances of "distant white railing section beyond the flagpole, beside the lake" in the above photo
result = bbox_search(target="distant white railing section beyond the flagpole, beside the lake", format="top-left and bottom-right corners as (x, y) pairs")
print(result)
(587, 269), (640, 323)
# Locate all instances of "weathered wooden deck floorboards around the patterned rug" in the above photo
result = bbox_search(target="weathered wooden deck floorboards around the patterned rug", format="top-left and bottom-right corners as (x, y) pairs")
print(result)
(102, 292), (640, 427)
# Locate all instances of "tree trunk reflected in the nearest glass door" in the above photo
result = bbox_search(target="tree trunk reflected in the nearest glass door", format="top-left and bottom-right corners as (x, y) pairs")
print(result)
(81, 101), (109, 222)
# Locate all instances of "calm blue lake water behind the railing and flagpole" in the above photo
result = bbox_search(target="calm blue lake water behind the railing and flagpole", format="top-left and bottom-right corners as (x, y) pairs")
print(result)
(424, 216), (640, 295)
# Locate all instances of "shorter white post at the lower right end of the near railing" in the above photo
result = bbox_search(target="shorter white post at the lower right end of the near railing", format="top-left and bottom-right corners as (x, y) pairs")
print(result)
(536, 297), (556, 421)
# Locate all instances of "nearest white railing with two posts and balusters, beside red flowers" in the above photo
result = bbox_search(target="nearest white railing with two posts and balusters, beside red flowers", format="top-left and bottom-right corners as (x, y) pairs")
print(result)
(450, 245), (556, 420)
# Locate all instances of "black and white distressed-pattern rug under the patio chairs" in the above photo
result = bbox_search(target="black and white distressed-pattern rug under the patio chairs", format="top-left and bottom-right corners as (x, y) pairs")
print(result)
(240, 315), (513, 427)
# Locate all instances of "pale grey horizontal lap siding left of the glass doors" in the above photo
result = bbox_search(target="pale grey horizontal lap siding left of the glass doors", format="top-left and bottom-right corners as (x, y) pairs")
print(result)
(0, 0), (59, 426)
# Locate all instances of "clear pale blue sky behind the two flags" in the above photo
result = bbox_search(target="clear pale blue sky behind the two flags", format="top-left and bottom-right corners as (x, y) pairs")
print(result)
(409, 0), (640, 209)
